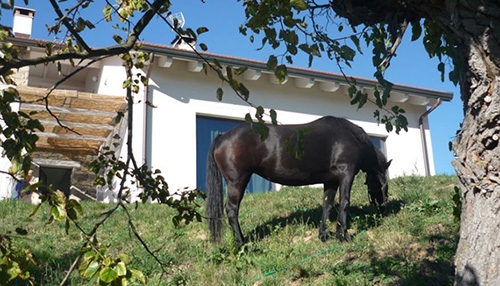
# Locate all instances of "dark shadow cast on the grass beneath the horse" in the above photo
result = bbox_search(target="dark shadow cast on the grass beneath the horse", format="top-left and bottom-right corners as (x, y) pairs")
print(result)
(247, 200), (402, 244)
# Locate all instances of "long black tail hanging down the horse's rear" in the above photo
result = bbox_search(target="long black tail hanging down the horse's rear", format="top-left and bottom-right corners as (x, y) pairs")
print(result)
(206, 137), (224, 241)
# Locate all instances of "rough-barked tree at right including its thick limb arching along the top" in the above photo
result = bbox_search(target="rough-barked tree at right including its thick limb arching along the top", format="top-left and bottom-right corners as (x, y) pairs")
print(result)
(330, 0), (500, 285)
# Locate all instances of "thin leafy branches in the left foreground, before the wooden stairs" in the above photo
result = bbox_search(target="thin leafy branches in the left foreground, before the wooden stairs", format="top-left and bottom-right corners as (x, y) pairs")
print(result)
(0, 0), (205, 285)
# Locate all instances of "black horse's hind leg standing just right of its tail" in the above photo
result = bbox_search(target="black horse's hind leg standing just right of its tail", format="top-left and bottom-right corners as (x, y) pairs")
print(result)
(226, 176), (250, 247)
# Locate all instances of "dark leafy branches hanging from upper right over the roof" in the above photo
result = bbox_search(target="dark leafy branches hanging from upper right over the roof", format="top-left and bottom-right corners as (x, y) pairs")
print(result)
(240, 0), (461, 133)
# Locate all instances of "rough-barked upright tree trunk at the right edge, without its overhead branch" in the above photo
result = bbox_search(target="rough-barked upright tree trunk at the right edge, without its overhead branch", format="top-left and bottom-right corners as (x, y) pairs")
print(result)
(453, 9), (500, 285)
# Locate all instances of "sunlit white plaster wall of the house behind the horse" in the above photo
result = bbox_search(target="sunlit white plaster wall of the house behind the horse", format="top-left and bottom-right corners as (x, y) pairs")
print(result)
(148, 58), (434, 192)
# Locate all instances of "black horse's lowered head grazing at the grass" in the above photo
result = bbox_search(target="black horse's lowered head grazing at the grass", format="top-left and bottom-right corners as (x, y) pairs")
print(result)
(365, 160), (392, 210)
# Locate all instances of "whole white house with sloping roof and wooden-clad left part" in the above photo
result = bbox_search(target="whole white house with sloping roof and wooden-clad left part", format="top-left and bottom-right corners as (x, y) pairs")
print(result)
(0, 7), (453, 200)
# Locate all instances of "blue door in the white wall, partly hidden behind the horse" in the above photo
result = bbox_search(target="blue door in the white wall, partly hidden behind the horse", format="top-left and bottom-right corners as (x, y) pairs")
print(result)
(196, 116), (272, 193)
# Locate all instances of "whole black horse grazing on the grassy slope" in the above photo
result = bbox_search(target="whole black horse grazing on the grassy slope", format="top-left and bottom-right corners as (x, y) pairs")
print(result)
(206, 116), (390, 246)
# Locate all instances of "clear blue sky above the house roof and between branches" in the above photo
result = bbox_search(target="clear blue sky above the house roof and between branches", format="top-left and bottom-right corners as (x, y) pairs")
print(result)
(0, 0), (463, 174)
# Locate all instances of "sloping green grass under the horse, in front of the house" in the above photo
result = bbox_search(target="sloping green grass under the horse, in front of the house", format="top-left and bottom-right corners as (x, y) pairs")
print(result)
(0, 176), (458, 285)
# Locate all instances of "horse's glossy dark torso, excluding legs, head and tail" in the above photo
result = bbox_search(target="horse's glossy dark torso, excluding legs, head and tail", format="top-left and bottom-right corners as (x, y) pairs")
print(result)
(214, 116), (376, 185)
